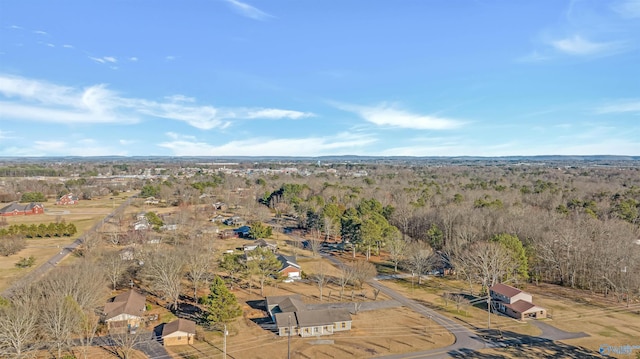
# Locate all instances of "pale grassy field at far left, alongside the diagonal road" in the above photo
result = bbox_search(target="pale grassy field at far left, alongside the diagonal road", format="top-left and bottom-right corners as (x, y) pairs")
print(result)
(0, 196), (126, 291)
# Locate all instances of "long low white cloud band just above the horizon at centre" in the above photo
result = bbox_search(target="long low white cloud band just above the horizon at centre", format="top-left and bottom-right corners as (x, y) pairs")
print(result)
(158, 133), (376, 156)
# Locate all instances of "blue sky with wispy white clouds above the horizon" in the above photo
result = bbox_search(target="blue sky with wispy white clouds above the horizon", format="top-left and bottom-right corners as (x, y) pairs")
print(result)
(0, 0), (640, 156)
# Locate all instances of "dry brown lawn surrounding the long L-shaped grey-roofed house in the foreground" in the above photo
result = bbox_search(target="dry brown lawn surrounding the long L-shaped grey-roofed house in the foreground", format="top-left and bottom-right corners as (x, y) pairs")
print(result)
(168, 307), (453, 359)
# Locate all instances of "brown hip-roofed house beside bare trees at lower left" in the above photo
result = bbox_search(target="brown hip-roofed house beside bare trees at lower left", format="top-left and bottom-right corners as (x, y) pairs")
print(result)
(104, 289), (146, 333)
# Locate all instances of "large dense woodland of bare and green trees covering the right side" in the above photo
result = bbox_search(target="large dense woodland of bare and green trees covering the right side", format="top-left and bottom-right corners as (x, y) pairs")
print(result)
(244, 164), (640, 298)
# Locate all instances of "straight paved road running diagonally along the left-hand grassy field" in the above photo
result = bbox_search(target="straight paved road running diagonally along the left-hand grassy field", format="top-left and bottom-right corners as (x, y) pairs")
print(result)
(0, 195), (137, 298)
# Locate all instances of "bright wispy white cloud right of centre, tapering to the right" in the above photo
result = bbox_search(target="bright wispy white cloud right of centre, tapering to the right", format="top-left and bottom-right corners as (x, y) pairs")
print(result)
(335, 103), (463, 130)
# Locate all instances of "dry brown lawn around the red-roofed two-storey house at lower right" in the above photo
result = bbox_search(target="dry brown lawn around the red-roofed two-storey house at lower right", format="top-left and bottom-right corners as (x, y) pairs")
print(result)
(383, 278), (640, 358)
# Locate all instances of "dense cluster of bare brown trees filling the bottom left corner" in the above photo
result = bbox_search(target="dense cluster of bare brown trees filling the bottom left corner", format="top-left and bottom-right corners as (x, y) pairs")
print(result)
(0, 261), (107, 358)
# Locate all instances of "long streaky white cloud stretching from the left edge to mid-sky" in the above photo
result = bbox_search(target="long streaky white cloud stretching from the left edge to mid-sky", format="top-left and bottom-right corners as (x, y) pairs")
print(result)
(0, 75), (313, 130)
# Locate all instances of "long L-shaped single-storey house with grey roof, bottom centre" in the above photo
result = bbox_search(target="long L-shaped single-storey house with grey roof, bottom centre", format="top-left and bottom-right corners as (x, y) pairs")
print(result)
(266, 295), (351, 337)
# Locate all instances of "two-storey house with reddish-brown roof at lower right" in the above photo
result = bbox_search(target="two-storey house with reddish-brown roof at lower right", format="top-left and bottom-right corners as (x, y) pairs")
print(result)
(489, 283), (547, 320)
